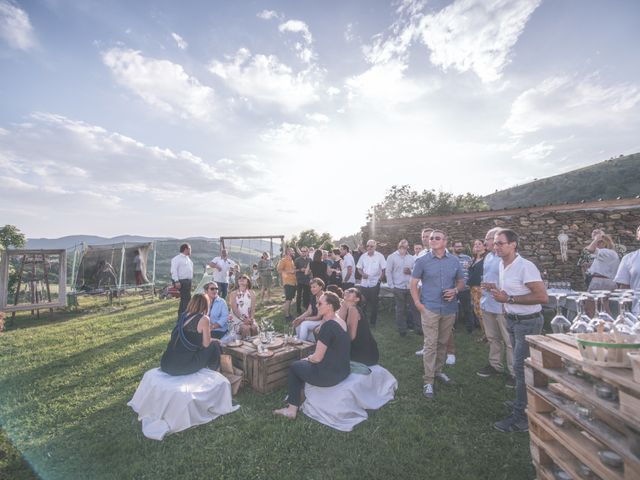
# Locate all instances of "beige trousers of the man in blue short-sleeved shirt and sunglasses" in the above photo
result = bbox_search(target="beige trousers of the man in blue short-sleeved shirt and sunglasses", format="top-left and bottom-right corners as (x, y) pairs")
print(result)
(421, 310), (456, 385)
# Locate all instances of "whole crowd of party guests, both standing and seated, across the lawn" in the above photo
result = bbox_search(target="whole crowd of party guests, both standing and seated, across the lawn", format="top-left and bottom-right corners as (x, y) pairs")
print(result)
(161, 226), (640, 432)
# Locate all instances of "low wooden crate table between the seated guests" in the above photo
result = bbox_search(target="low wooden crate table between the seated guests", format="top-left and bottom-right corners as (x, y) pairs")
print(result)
(224, 342), (315, 393)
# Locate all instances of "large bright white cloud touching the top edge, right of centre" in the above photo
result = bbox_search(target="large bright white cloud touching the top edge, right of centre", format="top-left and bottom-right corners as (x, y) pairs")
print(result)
(419, 0), (542, 82)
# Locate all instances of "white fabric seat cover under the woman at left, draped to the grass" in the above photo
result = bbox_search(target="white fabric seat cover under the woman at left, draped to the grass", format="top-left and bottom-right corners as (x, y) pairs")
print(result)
(127, 368), (240, 440)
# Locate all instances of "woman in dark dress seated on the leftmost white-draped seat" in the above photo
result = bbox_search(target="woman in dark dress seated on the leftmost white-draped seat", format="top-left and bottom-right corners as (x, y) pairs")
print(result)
(160, 293), (220, 375)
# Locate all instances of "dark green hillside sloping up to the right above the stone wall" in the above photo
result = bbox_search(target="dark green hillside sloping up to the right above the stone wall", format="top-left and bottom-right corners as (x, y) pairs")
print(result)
(484, 153), (640, 209)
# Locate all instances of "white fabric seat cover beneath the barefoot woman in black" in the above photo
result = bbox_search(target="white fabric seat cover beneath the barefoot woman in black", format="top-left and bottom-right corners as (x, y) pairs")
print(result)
(301, 365), (398, 432)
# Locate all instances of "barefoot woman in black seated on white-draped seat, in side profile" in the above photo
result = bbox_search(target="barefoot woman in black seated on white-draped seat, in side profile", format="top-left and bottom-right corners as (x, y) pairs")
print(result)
(273, 292), (351, 419)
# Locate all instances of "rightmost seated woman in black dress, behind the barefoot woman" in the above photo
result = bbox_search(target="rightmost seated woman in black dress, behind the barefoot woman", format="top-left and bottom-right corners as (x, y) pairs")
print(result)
(338, 288), (379, 366)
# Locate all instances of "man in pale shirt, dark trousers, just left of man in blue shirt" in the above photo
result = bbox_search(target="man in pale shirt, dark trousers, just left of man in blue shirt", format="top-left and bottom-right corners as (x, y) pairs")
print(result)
(386, 239), (416, 337)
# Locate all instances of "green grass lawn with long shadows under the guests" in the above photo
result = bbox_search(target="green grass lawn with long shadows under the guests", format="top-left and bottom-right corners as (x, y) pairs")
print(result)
(0, 290), (535, 480)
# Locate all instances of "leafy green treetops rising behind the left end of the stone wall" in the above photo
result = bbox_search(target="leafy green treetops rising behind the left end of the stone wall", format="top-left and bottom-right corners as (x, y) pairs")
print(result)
(367, 185), (489, 220)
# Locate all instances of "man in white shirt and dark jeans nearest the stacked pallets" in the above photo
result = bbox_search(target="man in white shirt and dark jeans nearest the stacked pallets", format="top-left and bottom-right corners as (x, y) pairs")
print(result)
(491, 229), (549, 432)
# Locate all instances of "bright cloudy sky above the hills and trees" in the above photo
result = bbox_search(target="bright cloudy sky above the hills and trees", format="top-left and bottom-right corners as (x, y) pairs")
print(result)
(0, 0), (640, 238)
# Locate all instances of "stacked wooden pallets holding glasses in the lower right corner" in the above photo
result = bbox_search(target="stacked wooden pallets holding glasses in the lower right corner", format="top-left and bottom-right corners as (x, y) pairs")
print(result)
(525, 335), (640, 480)
